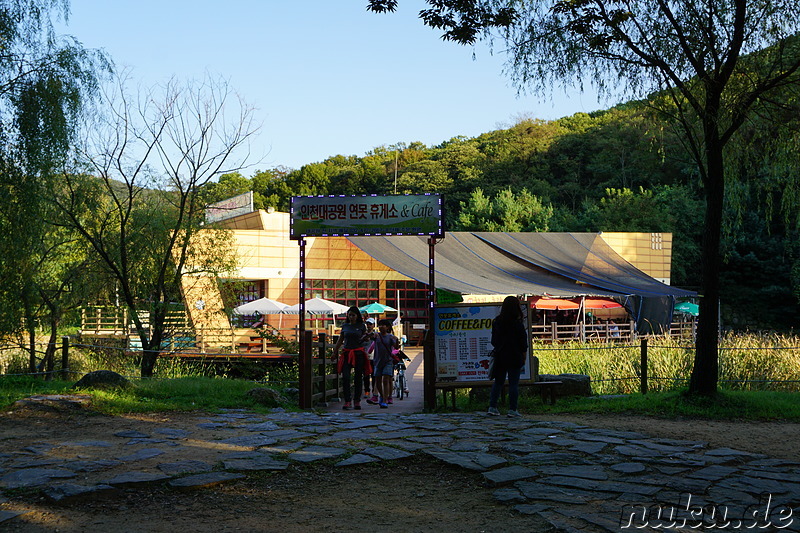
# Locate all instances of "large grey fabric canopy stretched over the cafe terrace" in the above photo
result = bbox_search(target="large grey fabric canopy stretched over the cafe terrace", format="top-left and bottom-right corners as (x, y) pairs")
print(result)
(348, 232), (695, 298)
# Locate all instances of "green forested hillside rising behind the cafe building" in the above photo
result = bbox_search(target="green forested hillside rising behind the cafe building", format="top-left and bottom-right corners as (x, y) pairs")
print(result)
(200, 102), (800, 329)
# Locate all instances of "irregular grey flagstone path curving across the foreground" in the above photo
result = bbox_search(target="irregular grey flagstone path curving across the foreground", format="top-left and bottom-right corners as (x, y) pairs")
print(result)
(0, 410), (800, 532)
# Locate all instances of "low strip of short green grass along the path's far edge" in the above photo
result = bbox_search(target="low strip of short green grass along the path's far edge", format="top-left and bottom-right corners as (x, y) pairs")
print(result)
(0, 377), (800, 422)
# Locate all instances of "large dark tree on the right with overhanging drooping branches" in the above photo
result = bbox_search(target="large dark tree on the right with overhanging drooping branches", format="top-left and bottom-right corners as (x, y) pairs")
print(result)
(368, 0), (800, 395)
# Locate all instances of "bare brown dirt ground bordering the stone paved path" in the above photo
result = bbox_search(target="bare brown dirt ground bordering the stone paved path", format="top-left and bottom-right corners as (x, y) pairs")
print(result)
(0, 406), (800, 533)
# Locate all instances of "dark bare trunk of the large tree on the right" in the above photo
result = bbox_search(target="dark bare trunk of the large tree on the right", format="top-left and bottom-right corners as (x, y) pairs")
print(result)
(689, 126), (725, 390)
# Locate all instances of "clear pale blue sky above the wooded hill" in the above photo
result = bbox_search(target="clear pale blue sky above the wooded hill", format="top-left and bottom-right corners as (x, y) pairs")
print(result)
(58, 0), (608, 170)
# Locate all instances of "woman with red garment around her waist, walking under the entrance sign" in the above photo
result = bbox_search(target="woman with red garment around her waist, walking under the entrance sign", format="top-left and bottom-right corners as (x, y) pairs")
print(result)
(333, 306), (372, 410)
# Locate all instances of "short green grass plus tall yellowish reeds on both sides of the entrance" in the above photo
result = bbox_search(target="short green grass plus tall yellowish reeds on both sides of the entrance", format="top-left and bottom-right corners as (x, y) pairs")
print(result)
(0, 333), (800, 422)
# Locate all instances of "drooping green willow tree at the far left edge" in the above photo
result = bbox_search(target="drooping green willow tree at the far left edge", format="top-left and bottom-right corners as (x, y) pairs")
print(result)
(0, 0), (109, 340)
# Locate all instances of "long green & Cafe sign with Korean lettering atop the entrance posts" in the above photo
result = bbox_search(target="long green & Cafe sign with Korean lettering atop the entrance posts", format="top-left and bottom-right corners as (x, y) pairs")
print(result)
(289, 194), (444, 239)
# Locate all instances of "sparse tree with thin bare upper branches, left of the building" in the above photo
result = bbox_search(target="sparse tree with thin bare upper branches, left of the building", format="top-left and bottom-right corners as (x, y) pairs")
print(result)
(53, 75), (256, 377)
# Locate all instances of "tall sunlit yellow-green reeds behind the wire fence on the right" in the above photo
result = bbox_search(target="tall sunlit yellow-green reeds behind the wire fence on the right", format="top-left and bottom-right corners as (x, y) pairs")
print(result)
(533, 333), (800, 394)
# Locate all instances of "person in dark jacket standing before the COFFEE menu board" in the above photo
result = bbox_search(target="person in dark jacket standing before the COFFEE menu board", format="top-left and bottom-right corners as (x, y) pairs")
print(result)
(489, 296), (528, 418)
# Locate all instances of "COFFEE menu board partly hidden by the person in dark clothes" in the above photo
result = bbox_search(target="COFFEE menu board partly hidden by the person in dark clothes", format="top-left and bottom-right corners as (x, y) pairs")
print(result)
(433, 303), (532, 387)
